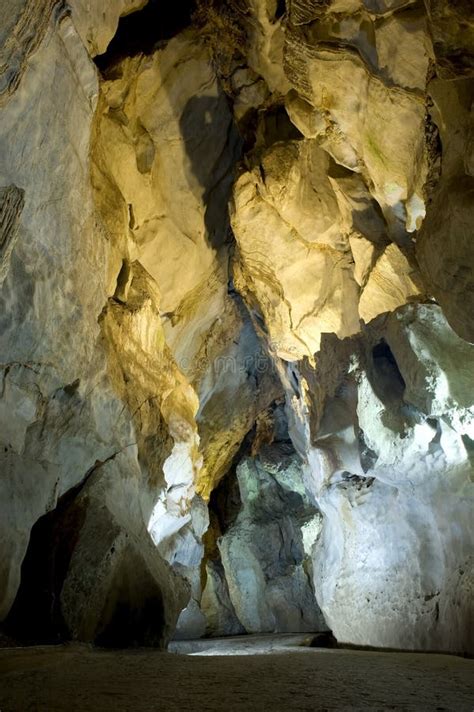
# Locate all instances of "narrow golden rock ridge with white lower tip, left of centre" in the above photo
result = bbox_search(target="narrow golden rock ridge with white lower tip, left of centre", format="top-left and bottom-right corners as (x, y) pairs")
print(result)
(101, 263), (202, 528)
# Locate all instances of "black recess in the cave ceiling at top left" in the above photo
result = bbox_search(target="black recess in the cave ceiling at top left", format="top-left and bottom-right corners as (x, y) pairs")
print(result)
(95, 0), (197, 74)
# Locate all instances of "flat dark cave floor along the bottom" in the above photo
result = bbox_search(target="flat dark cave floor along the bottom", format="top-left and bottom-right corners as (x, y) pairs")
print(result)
(0, 636), (474, 712)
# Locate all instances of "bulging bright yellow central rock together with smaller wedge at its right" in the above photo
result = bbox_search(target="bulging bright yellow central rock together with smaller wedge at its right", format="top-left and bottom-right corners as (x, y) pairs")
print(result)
(232, 140), (424, 361)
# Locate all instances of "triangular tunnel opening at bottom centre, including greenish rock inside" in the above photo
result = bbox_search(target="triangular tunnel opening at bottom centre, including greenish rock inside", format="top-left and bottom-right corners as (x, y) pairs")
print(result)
(172, 401), (330, 654)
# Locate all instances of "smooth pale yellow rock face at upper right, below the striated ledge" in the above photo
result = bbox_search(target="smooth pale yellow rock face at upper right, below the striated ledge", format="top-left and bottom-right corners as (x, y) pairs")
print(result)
(310, 51), (427, 234)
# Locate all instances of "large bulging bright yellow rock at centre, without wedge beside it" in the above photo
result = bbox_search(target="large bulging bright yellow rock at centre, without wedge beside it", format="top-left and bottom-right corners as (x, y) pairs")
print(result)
(232, 142), (358, 361)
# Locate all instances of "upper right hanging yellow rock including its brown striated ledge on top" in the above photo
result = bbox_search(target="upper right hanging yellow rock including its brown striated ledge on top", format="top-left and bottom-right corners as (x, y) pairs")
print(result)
(285, 2), (432, 240)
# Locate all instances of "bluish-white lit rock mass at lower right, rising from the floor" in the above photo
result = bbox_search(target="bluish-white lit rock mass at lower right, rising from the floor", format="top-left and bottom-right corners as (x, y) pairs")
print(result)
(284, 305), (474, 652)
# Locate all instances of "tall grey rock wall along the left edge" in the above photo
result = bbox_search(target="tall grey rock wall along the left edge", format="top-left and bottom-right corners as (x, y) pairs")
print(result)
(0, 3), (108, 618)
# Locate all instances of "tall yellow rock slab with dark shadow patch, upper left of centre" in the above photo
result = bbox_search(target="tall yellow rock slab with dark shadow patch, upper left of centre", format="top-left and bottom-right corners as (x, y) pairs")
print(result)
(93, 33), (238, 373)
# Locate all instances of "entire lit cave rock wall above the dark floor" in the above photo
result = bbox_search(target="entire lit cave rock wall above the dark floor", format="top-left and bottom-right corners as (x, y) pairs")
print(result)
(0, 0), (474, 650)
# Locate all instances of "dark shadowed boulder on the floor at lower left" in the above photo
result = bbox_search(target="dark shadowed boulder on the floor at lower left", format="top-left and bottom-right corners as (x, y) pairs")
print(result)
(7, 458), (189, 647)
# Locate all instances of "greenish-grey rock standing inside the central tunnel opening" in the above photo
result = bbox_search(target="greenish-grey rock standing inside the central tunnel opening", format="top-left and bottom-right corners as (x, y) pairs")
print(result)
(218, 443), (325, 634)
